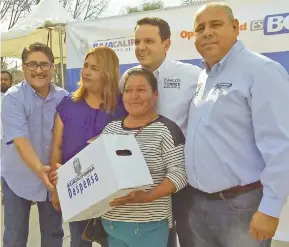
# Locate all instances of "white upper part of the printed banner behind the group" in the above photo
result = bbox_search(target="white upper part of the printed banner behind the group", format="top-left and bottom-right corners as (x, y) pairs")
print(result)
(66, 0), (289, 69)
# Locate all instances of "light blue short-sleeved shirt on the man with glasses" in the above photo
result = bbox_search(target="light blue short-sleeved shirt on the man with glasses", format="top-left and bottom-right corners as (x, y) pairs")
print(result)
(2, 81), (68, 201)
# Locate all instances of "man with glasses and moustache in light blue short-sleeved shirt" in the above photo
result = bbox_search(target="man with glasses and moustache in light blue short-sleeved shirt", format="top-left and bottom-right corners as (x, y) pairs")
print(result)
(2, 43), (68, 247)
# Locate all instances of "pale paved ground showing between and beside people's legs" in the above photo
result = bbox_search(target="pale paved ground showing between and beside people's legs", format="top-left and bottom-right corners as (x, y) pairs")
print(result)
(0, 199), (289, 247)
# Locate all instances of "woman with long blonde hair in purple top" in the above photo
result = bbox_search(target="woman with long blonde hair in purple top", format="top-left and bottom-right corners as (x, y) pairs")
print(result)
(51, 47), (126, 247)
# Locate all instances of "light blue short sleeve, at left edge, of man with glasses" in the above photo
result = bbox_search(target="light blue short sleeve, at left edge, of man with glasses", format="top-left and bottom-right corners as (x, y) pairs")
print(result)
(1, 93), (29, 144)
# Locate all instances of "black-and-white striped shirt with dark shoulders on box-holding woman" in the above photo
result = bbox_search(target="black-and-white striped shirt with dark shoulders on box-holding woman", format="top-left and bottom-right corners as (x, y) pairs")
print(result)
(102, 116), (187, 226)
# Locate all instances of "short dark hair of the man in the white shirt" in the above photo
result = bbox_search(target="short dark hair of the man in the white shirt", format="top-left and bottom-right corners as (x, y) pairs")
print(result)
(135, 17), (171, 42)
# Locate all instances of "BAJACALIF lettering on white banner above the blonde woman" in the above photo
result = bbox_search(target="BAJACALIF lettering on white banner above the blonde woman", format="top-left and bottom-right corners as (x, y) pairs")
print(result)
(93, 37), (134, 52)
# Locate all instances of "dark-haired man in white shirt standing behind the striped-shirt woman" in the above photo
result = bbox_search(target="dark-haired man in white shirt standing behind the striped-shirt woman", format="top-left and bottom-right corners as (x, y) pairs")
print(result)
(120, 17), (201, 247)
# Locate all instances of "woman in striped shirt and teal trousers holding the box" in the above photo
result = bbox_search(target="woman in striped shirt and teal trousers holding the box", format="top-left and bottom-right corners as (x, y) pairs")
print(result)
(102, 69), (187, 247)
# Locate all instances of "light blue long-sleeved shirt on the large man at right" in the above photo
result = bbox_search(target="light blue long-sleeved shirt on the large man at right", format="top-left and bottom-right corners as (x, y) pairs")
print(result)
(185, 41), (289, 217)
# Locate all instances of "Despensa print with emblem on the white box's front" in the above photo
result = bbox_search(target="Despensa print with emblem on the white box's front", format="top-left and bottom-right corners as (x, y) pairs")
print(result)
(67, 158), (98, 199)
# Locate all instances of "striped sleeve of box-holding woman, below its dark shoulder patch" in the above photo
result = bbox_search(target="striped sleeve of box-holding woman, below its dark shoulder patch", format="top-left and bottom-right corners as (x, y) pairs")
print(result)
(163, 144), (188, 192)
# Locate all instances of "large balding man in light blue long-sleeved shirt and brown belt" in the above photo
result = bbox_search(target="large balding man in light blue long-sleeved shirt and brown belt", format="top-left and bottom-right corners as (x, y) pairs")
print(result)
(182, 3), (289, 247)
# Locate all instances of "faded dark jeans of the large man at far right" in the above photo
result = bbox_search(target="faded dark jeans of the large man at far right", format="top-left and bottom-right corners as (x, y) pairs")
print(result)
(173, 186), (271, 247)
